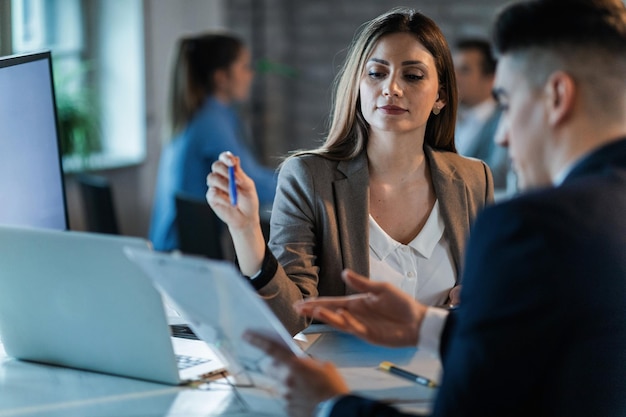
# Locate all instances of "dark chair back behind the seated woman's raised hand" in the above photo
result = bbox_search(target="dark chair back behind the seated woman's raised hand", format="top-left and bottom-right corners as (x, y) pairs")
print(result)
(176, 194), (226, 259)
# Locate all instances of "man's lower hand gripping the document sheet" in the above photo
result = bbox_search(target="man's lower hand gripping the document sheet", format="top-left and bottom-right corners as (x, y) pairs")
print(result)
(243, 331), (350, 417)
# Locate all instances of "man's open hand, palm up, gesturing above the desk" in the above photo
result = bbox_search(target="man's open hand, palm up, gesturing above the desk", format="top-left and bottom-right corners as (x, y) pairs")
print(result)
(294, 270), (426, 347)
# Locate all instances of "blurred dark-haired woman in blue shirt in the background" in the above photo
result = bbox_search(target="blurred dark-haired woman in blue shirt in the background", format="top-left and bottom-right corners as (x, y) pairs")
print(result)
(150, 33), (276, 251)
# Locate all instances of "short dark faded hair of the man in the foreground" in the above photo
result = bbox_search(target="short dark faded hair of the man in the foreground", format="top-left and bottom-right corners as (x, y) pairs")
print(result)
(493, 0), (626, 121)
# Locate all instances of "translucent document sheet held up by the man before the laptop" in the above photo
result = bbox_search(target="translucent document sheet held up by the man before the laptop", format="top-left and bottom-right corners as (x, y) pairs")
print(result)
(126, 247), (305, 383)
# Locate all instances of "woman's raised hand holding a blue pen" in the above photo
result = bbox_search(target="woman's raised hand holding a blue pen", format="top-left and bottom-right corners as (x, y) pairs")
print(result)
(206, 152), (265, 276)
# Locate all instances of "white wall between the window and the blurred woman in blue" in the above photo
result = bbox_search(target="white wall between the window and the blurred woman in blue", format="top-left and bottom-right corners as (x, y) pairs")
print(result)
(66, 0), (223, 237)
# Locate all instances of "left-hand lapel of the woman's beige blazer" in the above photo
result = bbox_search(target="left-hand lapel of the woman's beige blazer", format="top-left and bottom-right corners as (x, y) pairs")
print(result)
(333, 153), (369, 292)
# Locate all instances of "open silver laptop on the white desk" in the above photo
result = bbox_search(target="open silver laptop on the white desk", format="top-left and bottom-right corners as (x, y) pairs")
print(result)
(0, 226), (224, 385)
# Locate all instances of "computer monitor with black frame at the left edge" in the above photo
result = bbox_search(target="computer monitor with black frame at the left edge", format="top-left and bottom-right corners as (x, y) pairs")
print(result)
(0, 51), (69, 230)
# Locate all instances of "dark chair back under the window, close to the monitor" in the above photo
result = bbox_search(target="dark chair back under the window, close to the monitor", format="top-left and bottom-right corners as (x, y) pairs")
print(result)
(76, 174), (119, 235)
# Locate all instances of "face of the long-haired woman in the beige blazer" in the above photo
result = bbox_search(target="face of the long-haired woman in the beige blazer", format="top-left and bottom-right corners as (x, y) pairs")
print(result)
(359, 33), (445, 136)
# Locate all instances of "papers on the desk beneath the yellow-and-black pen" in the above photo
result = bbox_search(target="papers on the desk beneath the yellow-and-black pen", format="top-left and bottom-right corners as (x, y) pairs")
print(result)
(307, 331), (441, 412)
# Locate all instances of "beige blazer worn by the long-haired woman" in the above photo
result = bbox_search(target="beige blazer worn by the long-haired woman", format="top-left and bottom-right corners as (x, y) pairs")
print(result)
(259, 147), (493, 334)
